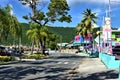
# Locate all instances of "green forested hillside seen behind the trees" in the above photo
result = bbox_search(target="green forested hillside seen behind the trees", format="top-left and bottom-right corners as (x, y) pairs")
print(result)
(2, 23), (100, 45)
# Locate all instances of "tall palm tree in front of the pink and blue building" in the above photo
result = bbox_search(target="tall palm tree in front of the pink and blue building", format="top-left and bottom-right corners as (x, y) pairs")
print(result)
(77, 9), (98, 52)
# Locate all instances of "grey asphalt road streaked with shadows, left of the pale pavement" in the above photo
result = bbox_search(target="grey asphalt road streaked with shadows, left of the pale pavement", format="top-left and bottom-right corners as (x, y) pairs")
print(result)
(0, 53), (82, 80)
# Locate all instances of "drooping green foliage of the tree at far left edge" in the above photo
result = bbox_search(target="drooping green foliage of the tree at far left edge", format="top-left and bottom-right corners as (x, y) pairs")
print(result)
(0, 5), (21, 46)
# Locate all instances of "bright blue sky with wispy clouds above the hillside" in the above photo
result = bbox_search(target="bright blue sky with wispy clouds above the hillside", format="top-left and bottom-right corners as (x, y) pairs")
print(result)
(0, 0), (120, 28)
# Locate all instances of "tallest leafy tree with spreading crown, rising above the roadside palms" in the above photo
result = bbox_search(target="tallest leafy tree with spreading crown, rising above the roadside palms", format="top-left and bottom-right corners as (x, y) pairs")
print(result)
(19, 0), (71, 53)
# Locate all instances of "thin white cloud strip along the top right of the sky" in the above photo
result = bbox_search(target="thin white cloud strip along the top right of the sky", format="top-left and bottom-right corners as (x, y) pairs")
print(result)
(67, 0), (120, 5)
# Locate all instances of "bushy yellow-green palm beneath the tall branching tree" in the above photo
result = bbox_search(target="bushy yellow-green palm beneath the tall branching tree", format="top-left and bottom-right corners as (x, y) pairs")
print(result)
(26, 23), (48, 52)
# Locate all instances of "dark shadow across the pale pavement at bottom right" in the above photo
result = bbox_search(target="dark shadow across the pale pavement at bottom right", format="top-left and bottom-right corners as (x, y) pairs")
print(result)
(72, 70), (118, 80)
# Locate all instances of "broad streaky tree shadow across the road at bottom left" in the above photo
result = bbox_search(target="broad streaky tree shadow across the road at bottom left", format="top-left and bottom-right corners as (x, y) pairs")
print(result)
(0, 66), (69, 80)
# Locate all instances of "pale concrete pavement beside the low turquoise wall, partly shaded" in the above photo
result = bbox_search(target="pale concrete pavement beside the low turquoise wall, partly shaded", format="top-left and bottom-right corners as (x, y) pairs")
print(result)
(73, 54), (119, 80)
